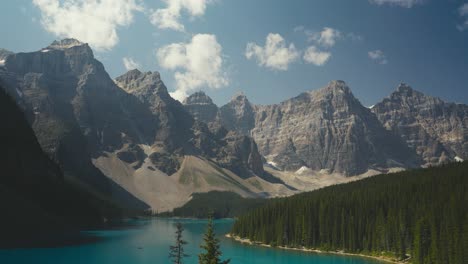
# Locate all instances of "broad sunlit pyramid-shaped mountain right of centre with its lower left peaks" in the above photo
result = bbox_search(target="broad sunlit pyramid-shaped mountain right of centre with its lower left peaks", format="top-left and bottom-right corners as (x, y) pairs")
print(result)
(184, 81), (418, 176)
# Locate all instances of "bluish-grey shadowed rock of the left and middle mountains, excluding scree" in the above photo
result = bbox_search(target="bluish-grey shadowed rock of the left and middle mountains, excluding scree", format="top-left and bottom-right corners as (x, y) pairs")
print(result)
(0, 39), (270, 208)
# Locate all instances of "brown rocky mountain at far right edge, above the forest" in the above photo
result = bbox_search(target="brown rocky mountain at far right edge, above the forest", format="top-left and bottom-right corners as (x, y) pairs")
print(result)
(372, 84), (468, 166)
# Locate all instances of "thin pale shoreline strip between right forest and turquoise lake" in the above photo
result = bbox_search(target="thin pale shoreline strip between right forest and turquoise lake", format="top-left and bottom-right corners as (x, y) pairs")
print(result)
(225, 234), (407, 264)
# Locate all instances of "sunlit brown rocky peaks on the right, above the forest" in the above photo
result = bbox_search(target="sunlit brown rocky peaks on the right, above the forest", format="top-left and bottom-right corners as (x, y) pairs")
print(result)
(185, 81), (460, 176)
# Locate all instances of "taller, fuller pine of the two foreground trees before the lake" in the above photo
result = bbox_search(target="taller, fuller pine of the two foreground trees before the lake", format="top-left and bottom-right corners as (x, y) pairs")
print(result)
(198, 217), (231, 264)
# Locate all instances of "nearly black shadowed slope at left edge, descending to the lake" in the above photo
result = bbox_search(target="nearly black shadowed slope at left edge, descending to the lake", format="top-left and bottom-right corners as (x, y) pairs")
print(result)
(0, 87), (111, 247)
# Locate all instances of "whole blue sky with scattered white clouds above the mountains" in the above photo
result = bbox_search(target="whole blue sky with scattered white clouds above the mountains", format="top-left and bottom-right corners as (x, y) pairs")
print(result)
(0, 0), (468, 106)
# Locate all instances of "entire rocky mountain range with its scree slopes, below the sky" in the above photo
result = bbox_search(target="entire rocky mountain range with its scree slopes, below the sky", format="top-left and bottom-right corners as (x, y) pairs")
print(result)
(0, 39), (468, 211)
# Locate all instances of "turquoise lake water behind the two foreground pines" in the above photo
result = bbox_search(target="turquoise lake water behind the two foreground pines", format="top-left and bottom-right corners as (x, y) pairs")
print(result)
(0, 219), (381, 264)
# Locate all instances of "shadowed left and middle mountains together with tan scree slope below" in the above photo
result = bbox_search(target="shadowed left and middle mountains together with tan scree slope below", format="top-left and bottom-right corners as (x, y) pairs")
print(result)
(0, 39), (288, 210)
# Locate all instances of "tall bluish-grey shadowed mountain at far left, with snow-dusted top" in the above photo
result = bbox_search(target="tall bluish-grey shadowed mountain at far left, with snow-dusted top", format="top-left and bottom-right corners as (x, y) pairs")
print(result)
(0, 39), (152, 209)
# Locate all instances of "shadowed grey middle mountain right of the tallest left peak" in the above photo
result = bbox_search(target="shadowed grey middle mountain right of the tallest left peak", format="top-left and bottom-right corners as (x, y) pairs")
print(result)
(116, 70), (264, 177)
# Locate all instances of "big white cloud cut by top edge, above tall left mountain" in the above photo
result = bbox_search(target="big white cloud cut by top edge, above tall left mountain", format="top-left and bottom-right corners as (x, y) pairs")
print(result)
(33, 0), (142, 50)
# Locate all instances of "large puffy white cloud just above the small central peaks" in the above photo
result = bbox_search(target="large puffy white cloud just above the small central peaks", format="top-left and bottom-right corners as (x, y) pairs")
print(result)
(156, 34), (229, 101)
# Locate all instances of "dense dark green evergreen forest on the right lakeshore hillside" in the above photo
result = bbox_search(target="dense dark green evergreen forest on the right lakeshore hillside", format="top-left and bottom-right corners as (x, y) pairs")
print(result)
(232, 162), (468, 264)
